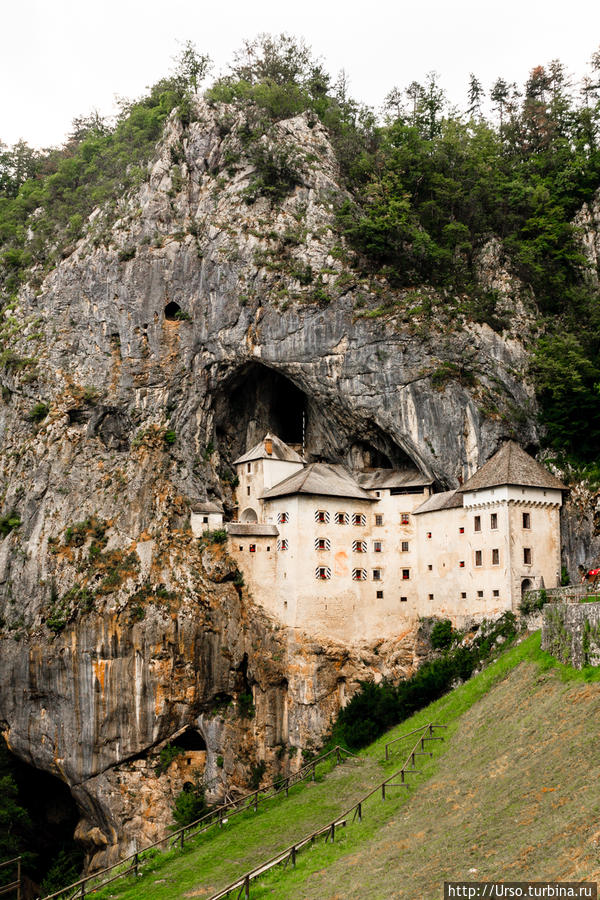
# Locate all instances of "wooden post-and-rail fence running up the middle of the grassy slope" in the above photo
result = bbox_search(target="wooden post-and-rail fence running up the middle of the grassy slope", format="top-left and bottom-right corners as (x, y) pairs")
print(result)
(208, 722), (448, 900)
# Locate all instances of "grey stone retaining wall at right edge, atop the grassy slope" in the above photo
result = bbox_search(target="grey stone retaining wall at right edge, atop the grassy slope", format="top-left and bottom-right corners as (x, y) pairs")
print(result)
(542, 603), (600, 669)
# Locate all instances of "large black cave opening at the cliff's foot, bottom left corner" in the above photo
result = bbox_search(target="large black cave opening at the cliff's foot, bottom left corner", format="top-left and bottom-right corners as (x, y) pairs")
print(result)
(0, 740), (84, 900)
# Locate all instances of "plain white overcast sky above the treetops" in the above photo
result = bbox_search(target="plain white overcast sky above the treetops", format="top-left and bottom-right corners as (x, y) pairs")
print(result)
(0, 0), (600, 146)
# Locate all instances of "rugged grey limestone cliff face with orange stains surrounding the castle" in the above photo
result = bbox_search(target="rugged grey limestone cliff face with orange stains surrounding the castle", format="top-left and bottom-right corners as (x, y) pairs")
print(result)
(0, 103), (552, 866)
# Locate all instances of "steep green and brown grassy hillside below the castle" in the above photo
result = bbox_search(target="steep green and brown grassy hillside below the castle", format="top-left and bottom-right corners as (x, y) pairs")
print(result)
(83, 635), (600, 900)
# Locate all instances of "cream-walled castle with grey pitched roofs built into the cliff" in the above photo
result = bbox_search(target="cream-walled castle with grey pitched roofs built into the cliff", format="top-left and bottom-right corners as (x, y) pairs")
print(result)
(196, 434), (566, 643)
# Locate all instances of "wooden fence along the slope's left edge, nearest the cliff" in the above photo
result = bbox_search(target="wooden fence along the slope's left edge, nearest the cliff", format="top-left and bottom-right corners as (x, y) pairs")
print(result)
(39, 746), (360, 900)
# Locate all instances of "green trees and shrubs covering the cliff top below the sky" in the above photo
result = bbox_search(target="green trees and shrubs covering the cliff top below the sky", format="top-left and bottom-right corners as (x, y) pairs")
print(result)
(0, 35), (600, 462)
